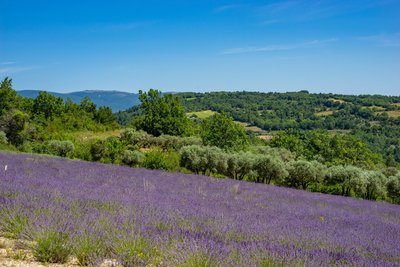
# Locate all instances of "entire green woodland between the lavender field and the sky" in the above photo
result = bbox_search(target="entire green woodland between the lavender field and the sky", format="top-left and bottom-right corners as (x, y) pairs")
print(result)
(0, 78), (400, 203)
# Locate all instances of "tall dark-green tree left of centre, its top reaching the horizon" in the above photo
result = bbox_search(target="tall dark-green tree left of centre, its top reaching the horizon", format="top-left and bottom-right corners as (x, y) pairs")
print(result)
(136, 89), (189, 136)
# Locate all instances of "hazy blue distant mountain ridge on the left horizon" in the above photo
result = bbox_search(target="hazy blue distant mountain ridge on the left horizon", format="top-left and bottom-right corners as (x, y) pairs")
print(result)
(17, 90), (140, 112)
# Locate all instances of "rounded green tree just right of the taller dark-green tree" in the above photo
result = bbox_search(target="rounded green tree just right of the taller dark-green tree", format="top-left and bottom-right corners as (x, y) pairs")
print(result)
(201, 114), (248, 150)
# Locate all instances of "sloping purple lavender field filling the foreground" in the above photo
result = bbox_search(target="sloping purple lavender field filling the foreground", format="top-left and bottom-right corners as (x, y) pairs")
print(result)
(0, 153), (400, 266)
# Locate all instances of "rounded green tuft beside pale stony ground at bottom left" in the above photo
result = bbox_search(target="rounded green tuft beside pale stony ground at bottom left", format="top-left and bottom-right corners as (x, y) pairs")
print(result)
(33, 230), (71, 263)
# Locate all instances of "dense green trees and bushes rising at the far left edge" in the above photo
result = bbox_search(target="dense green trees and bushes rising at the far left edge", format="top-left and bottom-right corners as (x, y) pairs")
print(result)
(0, 78), (118, 148)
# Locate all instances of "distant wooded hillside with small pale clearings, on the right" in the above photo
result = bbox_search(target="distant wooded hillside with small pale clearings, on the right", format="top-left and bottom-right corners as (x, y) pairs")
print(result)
(171, 91), (400, 165)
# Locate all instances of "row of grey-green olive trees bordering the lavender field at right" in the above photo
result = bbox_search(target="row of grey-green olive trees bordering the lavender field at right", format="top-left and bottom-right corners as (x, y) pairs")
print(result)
(180, 145), (400, 203)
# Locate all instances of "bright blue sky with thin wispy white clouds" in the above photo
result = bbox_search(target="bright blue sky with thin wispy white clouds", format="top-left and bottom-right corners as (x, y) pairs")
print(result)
(0, 0), (400, 95)
